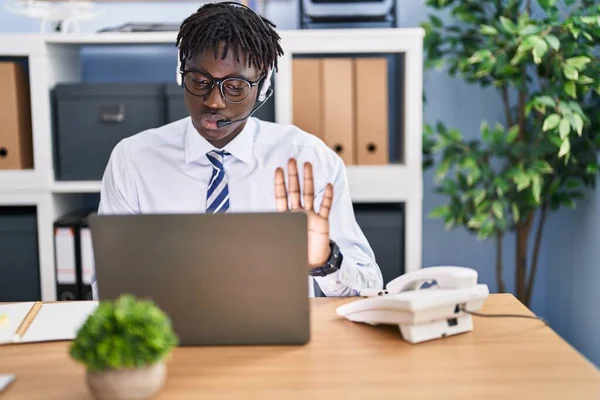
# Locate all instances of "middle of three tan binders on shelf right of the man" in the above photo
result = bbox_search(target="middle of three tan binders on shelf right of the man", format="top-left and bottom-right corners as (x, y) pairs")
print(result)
(322, 58), (356, 165)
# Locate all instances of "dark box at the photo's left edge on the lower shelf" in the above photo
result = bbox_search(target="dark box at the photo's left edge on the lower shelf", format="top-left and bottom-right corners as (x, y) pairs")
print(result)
(0, 207), (41, 302)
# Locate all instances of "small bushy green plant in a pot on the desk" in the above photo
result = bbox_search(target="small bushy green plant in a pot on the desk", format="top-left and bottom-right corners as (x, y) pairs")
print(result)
(69, 294), (178, 400)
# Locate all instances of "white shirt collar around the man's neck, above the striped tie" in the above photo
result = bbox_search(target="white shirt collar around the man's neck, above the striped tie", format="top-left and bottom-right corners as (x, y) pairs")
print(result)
(185, 118), (257, 164)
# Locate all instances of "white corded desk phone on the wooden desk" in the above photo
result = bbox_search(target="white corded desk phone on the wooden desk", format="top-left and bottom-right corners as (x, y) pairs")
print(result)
(337, 266), (489, 343)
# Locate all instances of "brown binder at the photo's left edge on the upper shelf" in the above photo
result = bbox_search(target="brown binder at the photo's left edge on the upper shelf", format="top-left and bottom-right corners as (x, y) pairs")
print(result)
(0, 62), (33, 170)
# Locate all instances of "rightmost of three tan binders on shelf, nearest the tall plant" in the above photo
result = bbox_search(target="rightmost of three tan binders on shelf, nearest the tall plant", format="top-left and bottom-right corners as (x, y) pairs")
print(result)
(354, 57), (390, 165)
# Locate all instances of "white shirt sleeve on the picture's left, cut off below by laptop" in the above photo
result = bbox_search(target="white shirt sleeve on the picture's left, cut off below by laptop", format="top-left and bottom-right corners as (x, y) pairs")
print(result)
(98, 141), (139, 214)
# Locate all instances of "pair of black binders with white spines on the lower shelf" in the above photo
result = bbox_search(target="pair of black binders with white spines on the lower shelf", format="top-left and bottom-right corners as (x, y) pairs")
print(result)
(54, 209), (95, 300)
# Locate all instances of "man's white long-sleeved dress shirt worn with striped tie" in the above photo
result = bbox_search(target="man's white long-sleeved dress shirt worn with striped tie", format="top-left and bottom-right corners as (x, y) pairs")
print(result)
(98, 117), (383, 296)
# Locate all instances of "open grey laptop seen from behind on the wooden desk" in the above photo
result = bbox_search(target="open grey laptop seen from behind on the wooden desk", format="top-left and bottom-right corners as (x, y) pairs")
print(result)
(89, 212), (310, 346)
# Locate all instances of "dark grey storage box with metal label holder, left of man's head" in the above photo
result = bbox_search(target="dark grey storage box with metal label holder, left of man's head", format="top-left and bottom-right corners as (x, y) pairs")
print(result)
(54, 83), (165, 181)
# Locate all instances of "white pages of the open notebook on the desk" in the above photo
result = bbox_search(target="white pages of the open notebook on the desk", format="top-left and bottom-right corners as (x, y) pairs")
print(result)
(0, 301), (98, 343)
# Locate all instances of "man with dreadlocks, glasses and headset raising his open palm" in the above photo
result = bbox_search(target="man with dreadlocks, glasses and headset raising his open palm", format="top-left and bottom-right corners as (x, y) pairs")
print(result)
(99, 3), (383, 296)
